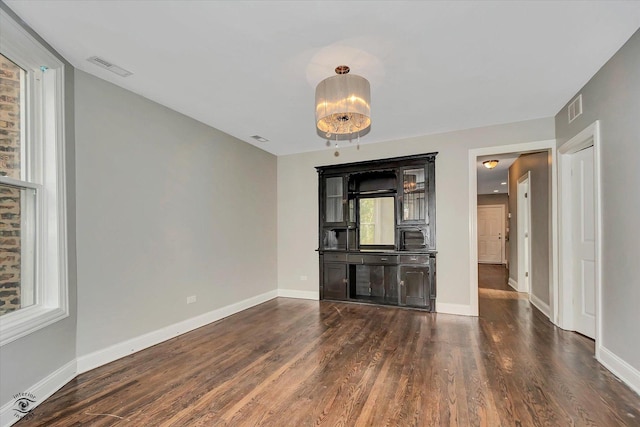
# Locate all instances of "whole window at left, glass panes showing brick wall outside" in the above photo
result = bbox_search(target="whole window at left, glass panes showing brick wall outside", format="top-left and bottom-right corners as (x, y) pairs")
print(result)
(0, 10), (68, 345)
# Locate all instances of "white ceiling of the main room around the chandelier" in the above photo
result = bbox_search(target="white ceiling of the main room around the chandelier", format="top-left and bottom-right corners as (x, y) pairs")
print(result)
(5, 0), (640, 155)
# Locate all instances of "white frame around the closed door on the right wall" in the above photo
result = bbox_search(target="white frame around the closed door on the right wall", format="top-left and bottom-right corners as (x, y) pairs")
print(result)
(553, 120), (602, 360)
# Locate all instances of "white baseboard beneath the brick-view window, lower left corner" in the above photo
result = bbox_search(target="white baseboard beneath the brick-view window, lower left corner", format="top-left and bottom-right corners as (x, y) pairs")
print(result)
(0, 359), (78, 427)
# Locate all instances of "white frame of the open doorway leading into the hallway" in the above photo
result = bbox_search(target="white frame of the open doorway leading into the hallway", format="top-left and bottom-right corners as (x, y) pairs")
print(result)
(465, 139), (558, 323)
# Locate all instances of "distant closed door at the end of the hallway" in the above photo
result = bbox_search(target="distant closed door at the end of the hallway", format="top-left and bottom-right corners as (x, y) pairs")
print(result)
(478, 205), (504, 264)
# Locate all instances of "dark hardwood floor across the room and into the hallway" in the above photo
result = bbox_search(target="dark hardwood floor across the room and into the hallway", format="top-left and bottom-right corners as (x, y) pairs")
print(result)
(16, 268), (640, 427)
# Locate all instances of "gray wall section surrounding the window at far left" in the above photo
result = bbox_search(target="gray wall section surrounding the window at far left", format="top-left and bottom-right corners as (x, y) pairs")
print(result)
(0, 2), (76, 407)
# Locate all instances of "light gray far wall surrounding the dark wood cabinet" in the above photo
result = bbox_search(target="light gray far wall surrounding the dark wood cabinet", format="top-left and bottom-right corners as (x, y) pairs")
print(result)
(278, 118), (554, 312)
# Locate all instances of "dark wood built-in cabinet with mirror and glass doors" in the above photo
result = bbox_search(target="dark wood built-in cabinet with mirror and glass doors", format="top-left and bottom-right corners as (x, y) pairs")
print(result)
(316, 153), (438, 311)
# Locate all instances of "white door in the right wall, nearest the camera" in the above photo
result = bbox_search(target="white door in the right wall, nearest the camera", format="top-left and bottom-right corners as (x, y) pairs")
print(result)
(571, 146), (596, 338)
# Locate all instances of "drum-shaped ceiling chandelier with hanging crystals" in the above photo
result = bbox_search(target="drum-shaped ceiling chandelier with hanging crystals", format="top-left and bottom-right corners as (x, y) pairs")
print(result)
(316, 65), (371, 156)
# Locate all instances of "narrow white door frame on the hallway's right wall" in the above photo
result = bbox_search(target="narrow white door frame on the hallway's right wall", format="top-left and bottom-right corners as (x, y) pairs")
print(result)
(516, 171), (533, 295)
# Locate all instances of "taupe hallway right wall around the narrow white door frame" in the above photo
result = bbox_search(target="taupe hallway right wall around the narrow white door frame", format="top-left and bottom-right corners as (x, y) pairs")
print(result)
(509, 151), (551, 304)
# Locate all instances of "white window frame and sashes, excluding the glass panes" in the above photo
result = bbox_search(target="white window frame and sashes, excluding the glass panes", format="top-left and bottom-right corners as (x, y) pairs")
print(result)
(0, 9), (69, 346)
